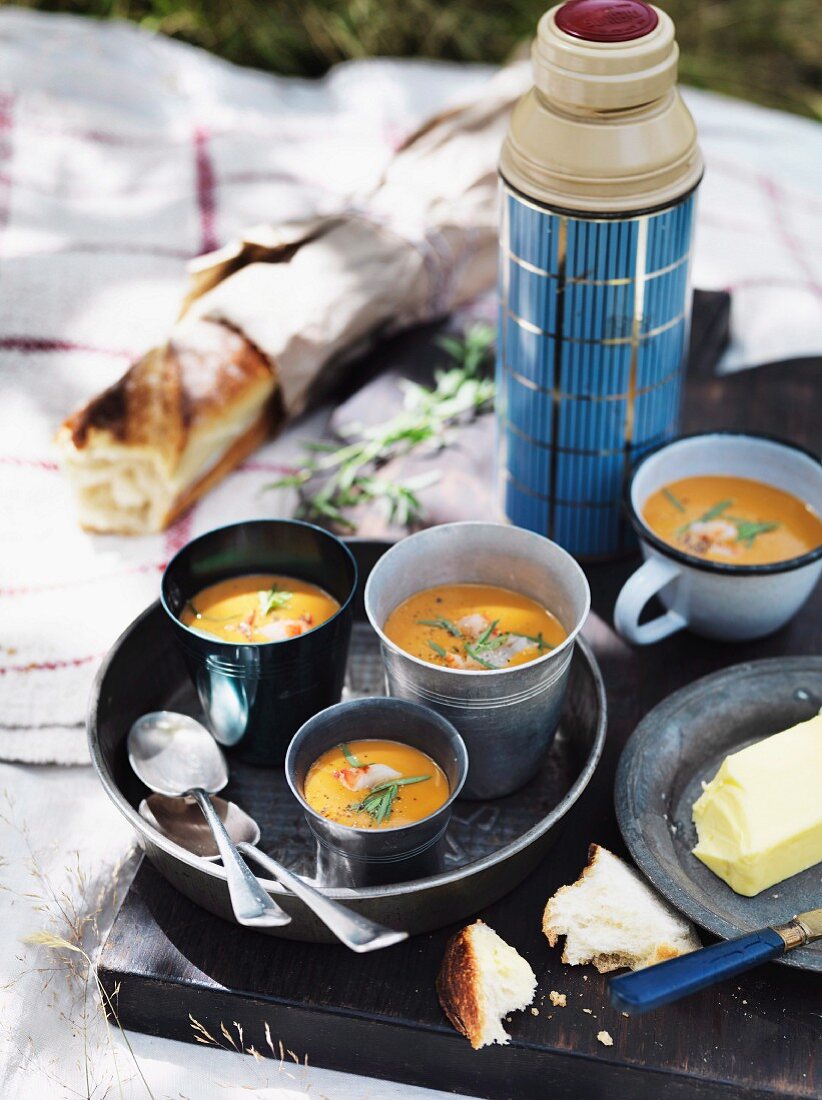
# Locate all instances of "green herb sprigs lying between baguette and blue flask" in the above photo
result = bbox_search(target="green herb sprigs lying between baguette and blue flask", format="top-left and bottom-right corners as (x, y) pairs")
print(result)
(264, 325), (495, 531)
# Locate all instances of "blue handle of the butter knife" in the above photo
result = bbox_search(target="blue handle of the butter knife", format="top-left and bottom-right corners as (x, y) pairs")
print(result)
(611, 928), (785, 1014)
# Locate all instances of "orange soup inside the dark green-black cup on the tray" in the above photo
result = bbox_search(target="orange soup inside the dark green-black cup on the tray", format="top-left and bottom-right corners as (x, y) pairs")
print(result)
(179, 573), (340, 645)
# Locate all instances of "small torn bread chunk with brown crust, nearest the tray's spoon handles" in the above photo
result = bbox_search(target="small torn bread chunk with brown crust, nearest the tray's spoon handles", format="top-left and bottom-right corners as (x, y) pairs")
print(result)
(437, 921), (537, 1051)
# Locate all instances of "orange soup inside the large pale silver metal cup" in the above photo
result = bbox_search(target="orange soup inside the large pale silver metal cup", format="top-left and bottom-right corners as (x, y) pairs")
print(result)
(383, 584), (568, 671)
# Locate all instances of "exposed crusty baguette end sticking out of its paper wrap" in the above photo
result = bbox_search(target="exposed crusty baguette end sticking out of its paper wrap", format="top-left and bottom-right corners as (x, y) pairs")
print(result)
(57, 320), (282, 535)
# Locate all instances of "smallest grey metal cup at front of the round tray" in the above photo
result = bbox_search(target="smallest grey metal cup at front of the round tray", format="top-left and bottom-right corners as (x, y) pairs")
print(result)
(285, 696), (468, 887)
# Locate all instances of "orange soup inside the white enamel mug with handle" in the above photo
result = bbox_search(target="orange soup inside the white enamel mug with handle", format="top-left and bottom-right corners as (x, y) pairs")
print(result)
(643, 475), (822, 565)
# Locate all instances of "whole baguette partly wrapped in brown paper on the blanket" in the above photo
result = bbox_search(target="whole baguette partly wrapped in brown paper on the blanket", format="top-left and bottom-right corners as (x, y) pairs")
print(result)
(57, 66), (528, 534)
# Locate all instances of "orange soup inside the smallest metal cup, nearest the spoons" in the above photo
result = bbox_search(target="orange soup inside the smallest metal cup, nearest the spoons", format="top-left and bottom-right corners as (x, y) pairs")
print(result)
(303, 740), (450, 828)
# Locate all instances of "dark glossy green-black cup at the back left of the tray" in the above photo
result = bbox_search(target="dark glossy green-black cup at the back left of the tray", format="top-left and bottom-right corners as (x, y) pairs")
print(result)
(161, 519), (357, 767)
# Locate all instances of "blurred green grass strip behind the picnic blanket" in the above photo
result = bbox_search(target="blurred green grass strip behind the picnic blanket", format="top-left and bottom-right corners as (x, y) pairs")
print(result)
(6, 0), (822, 118)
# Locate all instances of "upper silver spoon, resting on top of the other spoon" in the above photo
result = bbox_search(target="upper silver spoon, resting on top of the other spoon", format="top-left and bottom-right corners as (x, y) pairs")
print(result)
(128, 711), (291, 928)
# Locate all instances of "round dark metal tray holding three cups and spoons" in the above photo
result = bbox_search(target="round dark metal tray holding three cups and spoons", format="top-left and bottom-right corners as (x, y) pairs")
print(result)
(88, 540), (605, 943)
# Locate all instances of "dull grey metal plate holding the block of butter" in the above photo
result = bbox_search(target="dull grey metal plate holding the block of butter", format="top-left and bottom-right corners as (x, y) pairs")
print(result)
(615, 657), (822, 971)
